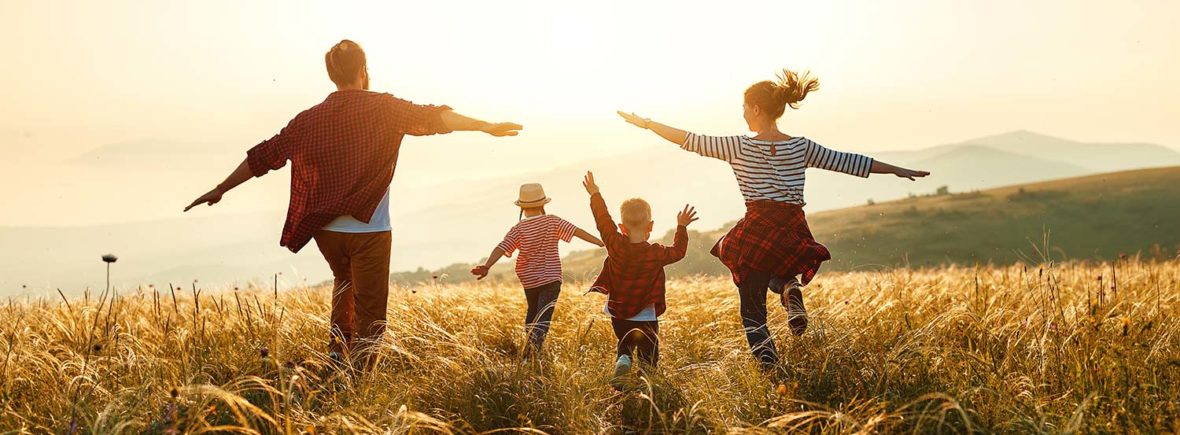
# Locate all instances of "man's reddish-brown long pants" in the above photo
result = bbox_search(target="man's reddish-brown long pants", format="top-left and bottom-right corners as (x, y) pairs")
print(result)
(315, 230), (392, 355)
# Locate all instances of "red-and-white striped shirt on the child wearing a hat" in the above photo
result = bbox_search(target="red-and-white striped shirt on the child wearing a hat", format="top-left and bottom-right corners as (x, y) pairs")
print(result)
(496, 215), (577, 289)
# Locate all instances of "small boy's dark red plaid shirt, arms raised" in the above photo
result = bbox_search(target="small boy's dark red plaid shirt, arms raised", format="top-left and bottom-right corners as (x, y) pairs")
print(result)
(590, 193), (688, 319)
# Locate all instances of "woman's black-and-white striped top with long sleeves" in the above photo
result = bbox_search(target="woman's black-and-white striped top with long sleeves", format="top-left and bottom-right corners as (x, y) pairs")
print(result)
(681, 133), (873, 205)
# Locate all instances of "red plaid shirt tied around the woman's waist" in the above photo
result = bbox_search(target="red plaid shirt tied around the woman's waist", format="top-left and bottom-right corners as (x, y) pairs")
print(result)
(712, 200), (832, 285)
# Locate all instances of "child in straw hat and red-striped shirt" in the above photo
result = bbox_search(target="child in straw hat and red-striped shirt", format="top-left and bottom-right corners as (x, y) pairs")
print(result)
(471, 184), (603, 357)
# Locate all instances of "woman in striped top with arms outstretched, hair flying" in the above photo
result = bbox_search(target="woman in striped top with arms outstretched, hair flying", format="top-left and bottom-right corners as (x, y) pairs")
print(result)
(618, 70), (930, 369)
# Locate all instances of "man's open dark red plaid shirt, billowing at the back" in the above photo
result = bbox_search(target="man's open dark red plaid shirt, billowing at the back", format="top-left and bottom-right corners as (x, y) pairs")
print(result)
(247, 90), (451, 252)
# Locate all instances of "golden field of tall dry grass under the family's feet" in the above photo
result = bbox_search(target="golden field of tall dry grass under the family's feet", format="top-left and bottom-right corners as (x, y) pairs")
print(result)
(0, 258), (1180, 434)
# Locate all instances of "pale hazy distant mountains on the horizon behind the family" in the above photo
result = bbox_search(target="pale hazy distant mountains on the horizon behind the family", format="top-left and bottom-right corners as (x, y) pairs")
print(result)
(0, 132), (1180, 295)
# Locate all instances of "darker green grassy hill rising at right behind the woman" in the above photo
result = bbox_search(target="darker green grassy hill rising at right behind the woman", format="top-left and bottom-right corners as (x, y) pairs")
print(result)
(403, 166), (1180, 283)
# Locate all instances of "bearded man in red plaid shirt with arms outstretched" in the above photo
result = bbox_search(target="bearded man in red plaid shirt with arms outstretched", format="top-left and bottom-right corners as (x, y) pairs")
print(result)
(184, 40), (522, 364)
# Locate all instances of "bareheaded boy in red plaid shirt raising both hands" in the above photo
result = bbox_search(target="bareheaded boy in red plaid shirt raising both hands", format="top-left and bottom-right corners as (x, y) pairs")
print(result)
(582, 172), (696, 390)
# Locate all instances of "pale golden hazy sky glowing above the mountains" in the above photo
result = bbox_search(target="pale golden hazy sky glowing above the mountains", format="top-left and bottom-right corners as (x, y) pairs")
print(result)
(0, 0), (1180, 226)
